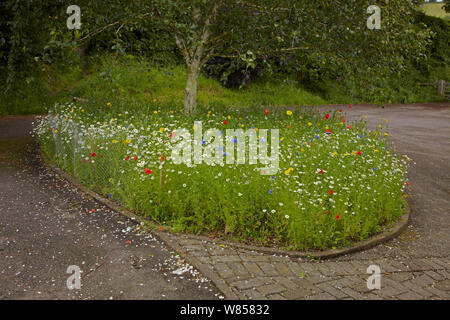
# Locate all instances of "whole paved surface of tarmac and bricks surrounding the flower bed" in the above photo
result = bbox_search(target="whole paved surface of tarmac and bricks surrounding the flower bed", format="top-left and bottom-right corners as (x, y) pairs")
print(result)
(0, 103), (450, 299)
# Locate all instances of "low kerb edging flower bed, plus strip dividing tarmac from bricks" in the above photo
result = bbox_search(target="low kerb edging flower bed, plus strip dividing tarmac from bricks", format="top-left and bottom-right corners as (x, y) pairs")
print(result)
(41, 159), (410, 299)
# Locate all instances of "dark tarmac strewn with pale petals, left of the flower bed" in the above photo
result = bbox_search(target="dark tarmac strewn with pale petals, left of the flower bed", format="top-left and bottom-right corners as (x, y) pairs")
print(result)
(0, 117), (220, 299)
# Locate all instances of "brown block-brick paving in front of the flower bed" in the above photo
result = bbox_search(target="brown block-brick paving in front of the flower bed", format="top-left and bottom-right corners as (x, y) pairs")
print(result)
(165, 235), (450, 300)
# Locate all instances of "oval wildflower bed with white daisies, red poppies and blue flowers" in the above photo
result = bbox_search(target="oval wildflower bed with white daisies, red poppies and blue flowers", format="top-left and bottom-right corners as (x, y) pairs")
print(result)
(35, 103), (408, 250)
